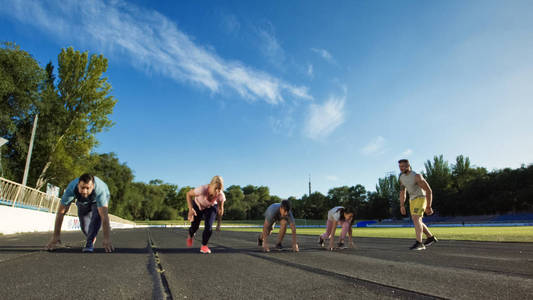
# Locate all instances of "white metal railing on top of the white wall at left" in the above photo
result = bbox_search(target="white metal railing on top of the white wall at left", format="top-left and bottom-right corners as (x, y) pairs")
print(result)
(0, 177), (78, 216)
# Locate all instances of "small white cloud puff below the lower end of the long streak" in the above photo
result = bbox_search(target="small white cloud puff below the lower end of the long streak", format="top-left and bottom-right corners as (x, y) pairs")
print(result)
(305, 96), (346, 140)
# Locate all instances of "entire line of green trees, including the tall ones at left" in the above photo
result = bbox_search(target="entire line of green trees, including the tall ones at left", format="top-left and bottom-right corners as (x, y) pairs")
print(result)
(0, 43), (533, 220)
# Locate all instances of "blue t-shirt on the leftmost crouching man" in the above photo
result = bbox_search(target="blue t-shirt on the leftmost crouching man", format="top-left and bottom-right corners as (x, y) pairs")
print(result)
(61, 176), (109, 207)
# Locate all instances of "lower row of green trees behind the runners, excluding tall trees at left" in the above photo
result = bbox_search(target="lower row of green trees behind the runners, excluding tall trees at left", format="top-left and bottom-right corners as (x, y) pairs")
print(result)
(83, 153), (533, 220)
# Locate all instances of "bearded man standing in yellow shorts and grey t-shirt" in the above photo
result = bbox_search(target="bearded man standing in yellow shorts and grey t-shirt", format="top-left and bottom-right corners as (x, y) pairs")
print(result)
(398, 159), (437, 250)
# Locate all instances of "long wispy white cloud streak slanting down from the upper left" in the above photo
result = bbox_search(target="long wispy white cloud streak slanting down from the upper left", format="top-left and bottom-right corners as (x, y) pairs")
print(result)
(0, 0), (312, 104)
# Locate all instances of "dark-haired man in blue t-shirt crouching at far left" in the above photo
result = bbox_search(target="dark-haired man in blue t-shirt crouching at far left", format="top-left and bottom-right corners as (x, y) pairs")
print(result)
(45, 174), (114, 252)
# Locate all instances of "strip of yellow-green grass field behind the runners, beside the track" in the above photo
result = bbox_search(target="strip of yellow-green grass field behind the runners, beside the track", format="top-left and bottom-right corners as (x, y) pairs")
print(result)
(223, 226), (533, 242)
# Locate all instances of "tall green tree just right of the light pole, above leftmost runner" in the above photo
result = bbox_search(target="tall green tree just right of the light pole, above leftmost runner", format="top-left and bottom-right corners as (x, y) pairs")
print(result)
(32, 48), (116, 189)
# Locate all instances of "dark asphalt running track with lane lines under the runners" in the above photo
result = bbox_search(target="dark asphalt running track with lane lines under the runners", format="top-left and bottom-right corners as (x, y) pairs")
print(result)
(0, 228), (533, 299)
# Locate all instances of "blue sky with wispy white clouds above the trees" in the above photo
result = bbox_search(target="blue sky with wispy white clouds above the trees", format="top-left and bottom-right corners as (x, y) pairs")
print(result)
(0, 0), (533, 197)
